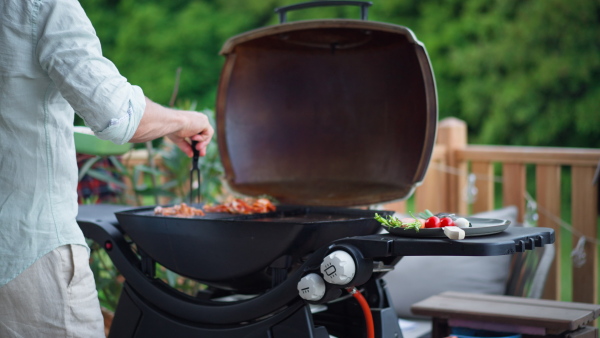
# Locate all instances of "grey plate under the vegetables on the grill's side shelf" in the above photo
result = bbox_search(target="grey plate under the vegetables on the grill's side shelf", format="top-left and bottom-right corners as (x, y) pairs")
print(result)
(384, 217), (510, 237)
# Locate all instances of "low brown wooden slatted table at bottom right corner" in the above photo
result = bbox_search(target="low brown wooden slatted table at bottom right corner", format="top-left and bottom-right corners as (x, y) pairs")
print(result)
(411, 292), (600, 338)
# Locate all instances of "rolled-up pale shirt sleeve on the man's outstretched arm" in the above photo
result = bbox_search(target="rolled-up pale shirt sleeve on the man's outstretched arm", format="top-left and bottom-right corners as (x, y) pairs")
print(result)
(35, 0), (146, 144)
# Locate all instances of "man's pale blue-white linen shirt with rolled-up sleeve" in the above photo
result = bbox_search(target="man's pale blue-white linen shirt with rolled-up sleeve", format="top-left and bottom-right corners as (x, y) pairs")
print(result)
(0, 0), (145, 287)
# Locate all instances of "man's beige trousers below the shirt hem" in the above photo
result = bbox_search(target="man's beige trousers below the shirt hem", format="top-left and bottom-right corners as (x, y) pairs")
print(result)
(0, 245), (105, 338)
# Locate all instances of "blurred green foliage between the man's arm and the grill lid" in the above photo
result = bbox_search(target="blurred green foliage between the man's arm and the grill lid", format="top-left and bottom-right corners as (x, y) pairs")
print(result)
(81, 0), (290, 109)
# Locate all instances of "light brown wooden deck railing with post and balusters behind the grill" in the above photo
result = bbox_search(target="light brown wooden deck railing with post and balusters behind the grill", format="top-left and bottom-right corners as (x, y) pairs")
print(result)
(384, 118), (600, 303)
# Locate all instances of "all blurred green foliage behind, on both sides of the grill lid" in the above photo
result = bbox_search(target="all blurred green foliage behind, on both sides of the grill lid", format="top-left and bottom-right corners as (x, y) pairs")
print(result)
(81, 0), (600, 147)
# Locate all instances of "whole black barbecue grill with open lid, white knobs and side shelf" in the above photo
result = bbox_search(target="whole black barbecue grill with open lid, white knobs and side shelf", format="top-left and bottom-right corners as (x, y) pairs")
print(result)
(78, 1), (554, 338)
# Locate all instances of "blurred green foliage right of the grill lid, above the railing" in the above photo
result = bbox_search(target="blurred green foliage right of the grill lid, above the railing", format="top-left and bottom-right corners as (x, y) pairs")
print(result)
(418, 0), (600, 147)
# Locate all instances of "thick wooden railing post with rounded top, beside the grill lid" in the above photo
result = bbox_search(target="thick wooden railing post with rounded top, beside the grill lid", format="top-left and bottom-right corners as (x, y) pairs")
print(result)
(437, 117), (468, 215)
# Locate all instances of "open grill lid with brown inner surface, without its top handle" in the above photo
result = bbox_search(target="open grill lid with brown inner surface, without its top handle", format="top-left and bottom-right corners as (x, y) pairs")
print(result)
(217, 19), (437, 206)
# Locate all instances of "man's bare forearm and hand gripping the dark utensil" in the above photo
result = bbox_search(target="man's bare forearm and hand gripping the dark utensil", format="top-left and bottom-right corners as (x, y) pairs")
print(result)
(129, 98), (214, 157)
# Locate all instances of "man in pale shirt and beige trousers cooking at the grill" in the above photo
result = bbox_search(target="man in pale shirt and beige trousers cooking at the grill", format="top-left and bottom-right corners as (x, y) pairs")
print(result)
(0, 0), (213, 337)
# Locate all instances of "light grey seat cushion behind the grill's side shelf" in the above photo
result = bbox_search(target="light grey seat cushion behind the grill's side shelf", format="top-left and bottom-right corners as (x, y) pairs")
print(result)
(384, 206), (518, 318)
